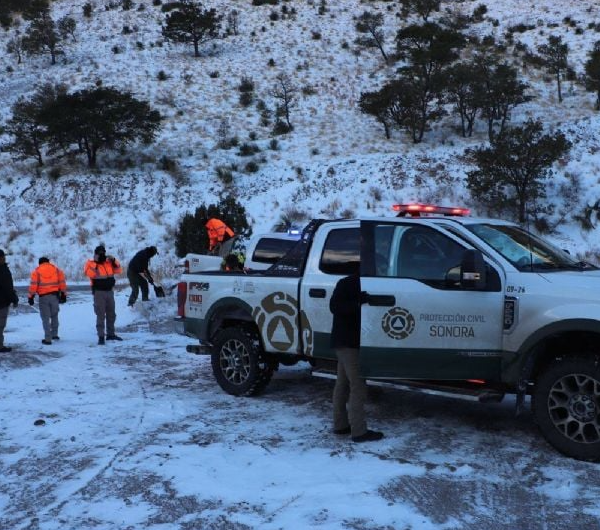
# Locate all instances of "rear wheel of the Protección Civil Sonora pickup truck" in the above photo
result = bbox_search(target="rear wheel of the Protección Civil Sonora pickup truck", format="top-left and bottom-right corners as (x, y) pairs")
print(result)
(211, 328), (274, 396)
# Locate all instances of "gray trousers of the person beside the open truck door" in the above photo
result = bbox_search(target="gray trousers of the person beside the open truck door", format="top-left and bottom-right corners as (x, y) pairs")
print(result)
(333, 348), (367, 437)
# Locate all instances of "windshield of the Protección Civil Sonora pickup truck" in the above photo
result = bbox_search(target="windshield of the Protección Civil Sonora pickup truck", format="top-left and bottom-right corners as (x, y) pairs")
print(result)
(467, 224), (596, 272)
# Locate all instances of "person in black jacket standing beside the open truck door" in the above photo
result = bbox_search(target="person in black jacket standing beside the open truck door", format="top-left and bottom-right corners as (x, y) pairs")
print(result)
(329, 263), (383, 442)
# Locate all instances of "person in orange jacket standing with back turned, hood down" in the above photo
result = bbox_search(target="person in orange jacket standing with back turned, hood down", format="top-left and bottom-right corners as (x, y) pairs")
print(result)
(28, 257), (67, 345)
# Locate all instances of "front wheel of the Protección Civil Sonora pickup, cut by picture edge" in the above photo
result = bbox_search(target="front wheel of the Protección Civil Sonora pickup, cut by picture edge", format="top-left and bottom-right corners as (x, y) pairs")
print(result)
(532, 358), (600, 462)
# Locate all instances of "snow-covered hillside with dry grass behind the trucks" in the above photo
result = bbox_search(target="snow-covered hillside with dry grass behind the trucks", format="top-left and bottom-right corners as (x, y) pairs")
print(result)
(0, 0), (600, 279)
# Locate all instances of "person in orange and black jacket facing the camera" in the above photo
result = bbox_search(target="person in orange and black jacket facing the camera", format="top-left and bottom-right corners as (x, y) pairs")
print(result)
(83, 245), (123, 345)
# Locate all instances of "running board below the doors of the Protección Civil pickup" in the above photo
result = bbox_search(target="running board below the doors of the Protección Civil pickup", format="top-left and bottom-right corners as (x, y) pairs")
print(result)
(312, 369), (504, 403)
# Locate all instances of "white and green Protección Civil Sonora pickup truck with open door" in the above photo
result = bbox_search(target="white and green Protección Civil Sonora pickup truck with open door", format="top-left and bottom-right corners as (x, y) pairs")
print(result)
(179, 204), (600, 461)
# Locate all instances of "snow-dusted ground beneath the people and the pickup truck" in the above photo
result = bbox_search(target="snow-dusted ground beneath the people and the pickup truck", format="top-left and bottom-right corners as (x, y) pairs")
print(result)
(0, 289), (600, 530)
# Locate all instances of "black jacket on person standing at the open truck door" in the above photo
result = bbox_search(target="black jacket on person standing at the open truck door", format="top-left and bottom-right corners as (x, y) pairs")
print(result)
(329, 274), (362, 348)
